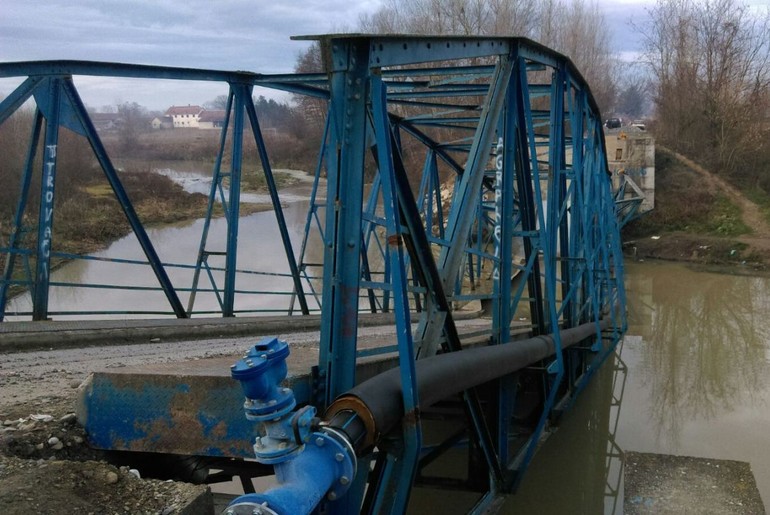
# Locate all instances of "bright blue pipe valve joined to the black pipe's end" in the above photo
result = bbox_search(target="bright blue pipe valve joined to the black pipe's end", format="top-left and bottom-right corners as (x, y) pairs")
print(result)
(225, 337), (356, 515)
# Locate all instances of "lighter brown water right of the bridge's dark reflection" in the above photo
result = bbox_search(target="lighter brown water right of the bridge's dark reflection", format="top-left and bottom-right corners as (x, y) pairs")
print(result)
(618, 263), (770, 502)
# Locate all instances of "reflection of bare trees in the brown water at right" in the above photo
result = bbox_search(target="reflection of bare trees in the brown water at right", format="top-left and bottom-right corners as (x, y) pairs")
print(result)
(627, 265), (770, 447)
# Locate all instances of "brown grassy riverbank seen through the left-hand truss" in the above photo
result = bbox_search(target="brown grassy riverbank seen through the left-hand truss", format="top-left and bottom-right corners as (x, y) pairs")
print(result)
(0, 159), (312, 297)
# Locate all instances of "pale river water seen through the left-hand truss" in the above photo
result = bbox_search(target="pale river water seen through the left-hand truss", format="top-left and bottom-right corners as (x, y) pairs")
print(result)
(7, 201), (322, 320)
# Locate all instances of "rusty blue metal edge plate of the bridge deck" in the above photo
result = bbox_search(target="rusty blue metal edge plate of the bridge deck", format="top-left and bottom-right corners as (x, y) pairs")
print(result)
(78, 320), (504, 458)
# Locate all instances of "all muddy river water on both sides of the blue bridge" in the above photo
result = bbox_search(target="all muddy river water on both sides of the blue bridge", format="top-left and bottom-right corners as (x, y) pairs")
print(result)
(6, 166), (770, 514)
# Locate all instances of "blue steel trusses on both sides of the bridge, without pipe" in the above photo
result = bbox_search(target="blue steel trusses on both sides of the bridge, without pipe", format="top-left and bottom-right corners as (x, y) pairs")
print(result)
(0, 35), (625, 513)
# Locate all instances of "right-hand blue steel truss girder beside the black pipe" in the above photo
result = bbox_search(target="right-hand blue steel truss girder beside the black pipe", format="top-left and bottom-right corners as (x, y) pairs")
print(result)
(306, 36), (625, 513)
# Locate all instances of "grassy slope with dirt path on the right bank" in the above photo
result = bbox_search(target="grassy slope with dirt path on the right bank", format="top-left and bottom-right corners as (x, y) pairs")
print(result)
(623, 146), (770, 270)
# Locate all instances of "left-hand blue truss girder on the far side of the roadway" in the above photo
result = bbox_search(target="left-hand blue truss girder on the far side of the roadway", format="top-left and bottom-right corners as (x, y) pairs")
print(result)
(0, 61), (316, 321)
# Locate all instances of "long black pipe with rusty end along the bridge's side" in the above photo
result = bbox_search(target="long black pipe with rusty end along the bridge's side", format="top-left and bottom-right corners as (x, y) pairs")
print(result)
(324, 317), (610, 451)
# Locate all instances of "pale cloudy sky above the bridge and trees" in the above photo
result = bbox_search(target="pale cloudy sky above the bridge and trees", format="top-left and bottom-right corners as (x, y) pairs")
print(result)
(0, 0), (770, 110)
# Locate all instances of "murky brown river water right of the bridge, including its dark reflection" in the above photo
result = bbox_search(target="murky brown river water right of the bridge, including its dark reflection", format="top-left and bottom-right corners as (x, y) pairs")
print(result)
(496, 262), (770, 514)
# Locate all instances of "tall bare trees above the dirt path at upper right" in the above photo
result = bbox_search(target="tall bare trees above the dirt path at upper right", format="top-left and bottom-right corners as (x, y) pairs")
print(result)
(640, 0), (770, 177)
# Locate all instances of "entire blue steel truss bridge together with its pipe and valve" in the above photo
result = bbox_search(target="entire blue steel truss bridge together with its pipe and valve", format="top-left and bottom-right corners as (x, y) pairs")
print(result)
(0, 35), (641, 514)
